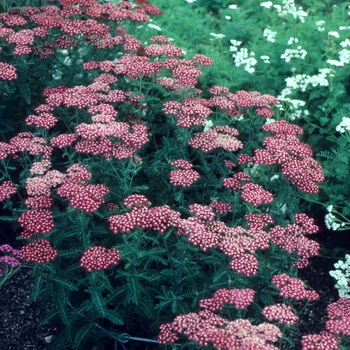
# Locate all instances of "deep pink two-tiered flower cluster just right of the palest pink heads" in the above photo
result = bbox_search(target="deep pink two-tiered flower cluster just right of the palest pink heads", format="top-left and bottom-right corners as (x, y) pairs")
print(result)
(57, 164), (109, 213)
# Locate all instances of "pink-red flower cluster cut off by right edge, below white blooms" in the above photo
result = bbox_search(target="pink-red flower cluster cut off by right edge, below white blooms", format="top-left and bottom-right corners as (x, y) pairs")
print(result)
(326, 298), (350, 337)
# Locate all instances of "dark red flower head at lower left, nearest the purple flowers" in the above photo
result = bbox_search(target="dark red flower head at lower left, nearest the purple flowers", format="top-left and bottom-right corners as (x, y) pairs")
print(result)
(19, 238), (58, 264)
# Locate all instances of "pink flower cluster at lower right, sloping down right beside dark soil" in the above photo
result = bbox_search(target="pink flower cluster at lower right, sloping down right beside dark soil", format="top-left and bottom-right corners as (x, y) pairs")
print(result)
(271, 273), (320, 301)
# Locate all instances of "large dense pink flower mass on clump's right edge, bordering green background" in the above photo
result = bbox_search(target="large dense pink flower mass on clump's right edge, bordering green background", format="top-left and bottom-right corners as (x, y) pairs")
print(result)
(239, 120), (324, 193)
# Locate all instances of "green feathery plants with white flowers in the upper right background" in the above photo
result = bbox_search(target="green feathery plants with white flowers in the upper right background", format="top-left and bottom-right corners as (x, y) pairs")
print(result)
(151, 0), (350, 230)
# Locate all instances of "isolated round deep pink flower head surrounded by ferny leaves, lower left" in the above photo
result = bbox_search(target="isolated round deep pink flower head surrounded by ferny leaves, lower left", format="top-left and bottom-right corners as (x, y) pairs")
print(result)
(80, 246), (120, 272)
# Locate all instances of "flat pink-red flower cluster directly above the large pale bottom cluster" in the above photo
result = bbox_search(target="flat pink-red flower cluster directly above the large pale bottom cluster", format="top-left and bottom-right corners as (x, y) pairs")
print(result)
(198, 288), (255, 312)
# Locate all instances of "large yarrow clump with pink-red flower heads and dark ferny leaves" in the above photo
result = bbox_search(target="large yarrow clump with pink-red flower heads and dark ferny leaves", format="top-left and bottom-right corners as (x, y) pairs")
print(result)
(0, 0), (347, 349)
